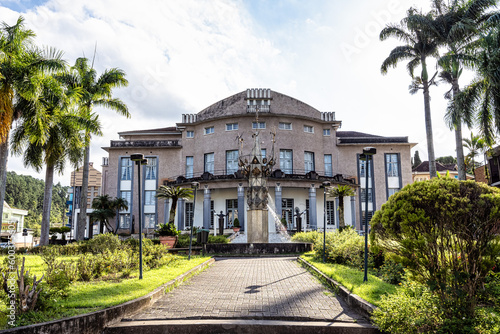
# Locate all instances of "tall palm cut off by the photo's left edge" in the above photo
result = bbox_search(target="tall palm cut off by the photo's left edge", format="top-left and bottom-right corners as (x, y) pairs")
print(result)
(0, 17), (65, 222)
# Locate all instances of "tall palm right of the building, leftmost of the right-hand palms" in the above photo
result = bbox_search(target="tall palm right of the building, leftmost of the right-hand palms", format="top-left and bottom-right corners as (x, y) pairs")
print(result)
(380, 8), (438, 177)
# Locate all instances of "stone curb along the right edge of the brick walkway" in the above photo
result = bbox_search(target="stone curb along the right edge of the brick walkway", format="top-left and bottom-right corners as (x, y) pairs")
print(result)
(297, 257), (377, 320)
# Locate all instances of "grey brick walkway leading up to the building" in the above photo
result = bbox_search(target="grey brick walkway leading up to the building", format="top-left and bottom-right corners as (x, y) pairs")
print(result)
(130, 257), (366, 323)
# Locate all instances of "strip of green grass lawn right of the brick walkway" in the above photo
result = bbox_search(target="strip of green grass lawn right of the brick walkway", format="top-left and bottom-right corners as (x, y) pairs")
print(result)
(301, 252), (397, 306)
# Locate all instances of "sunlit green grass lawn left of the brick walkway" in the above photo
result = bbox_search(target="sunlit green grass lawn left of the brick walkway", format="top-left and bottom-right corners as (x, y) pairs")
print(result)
(0, 255), (210, 329)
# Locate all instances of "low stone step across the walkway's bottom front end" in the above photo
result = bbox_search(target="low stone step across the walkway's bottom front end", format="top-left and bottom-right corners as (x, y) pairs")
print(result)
(103, 319), (380, 334)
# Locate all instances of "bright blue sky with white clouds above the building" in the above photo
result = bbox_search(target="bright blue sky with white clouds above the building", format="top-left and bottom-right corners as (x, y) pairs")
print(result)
(0, 0), (480, 185)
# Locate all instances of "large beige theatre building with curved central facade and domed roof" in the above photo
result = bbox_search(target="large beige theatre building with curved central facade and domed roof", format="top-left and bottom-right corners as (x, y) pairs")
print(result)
(102, 89), (414, 234)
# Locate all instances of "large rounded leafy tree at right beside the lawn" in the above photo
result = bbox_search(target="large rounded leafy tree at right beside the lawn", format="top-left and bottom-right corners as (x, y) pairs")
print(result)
(371, 178), (500, 319)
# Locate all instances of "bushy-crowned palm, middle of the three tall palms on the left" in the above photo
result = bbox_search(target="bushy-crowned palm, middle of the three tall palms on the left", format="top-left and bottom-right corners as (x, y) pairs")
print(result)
(11, 76), (97, 245)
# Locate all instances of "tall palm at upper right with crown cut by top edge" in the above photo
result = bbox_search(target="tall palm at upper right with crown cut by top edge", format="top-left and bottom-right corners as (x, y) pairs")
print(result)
(429, 0), (496, 180)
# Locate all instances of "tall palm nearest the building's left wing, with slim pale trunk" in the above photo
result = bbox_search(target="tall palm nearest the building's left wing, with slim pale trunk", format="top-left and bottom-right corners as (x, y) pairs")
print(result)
(61, 58), (130, 240)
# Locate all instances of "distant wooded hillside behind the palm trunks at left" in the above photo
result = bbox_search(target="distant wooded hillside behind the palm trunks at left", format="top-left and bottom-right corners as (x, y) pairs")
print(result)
(5, 172), (68, 234)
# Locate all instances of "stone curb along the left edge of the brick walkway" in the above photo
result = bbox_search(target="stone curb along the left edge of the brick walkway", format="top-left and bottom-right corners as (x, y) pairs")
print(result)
(0, 258), (215, 334)
